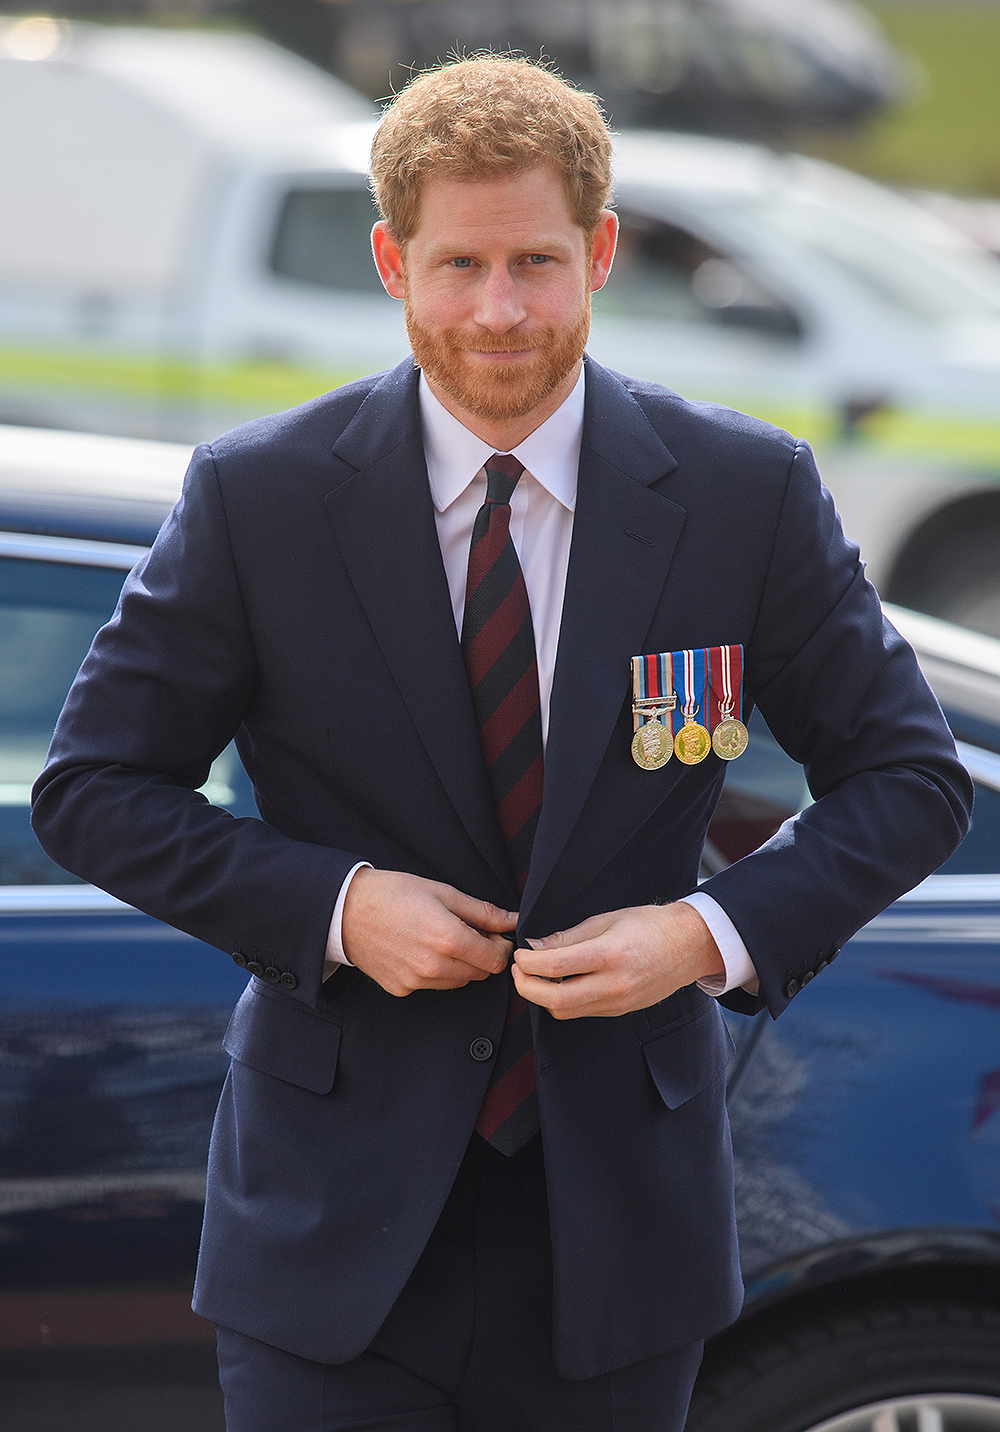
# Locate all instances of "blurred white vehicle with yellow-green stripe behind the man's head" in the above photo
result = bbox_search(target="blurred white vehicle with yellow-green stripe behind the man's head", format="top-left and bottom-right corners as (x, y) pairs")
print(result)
(0, 17), (1000, 636)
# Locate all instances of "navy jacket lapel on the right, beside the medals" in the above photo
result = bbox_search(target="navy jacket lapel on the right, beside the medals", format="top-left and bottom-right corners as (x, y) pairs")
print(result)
(521, 359), (685, 916)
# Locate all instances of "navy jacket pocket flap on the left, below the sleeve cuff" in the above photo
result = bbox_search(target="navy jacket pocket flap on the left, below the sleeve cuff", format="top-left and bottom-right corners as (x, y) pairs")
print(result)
(222, 984), (341, 1094)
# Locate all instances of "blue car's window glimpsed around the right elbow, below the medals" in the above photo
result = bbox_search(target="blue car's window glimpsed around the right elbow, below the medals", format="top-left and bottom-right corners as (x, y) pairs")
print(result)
(703, 710), (1000, 875)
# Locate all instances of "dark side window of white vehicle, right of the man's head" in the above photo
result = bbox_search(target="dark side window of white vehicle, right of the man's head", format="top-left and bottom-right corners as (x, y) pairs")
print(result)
(593, 209), (801, 339)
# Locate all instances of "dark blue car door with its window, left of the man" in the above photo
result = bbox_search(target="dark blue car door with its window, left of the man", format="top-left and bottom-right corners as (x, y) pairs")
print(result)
(0, 533), (242, 1432)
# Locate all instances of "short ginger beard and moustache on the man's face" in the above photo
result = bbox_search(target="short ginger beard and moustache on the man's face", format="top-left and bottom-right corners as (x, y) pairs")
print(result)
(403, 266), (590, 422)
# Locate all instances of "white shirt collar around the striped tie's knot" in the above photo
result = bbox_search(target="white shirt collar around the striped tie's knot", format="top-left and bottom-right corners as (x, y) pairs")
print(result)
(420, 368), (585, 513)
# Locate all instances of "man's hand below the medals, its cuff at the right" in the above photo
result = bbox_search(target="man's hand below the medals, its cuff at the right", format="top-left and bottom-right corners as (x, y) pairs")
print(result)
(513, 904), (725, 1020)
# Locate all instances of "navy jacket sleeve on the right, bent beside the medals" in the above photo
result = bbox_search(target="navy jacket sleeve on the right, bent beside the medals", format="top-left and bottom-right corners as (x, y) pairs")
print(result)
(701, 444), (973, 1015)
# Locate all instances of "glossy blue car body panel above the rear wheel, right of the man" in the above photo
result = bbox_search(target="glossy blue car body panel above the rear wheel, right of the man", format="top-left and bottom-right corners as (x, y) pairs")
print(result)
(728, 899), (1000, 1316)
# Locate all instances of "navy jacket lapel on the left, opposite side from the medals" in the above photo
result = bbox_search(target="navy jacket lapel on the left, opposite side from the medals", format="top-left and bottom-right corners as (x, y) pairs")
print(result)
(325, 361), (511, 886)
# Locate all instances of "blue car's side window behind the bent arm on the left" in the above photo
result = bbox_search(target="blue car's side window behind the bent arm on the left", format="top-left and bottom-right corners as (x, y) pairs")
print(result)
(0, 557), (255, 885)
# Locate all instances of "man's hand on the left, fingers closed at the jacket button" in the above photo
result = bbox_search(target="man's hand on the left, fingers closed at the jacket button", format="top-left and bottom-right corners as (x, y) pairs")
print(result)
(342, 869), (517, 997)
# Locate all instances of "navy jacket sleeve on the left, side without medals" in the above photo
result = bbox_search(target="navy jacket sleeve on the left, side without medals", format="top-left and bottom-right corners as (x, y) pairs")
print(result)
(32, 447), (357, 1004)
